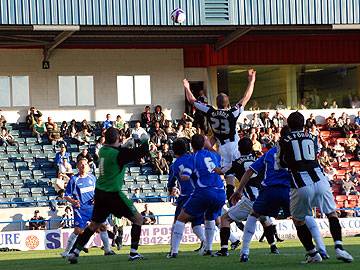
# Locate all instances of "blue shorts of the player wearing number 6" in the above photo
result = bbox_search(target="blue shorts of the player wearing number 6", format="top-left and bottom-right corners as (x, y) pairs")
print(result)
(183, 188), (226, 220)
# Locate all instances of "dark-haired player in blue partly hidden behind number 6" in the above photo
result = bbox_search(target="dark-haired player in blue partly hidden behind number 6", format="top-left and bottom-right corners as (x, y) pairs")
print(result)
(167, 138), (205, 258)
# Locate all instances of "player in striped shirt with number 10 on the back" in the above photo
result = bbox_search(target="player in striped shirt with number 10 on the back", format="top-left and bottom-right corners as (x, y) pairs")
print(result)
(279, 111), (353, 263)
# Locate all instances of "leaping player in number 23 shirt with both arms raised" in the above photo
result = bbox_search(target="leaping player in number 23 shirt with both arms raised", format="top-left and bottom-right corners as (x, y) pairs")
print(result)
(183, 69), (256, 204)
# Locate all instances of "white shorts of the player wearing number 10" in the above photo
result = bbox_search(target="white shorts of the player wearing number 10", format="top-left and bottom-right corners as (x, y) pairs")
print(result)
(290, 177), (336, 221)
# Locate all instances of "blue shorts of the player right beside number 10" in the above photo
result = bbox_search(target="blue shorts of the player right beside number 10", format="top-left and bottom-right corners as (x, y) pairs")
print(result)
(253, 186), (290, 217)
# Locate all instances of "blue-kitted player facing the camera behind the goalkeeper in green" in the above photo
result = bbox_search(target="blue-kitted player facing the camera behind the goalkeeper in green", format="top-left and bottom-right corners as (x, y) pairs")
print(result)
(61, 158), (115, 258)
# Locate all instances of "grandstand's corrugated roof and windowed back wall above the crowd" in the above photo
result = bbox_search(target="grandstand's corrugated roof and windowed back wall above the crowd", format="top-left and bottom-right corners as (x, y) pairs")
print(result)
(0, 0), (360, 122)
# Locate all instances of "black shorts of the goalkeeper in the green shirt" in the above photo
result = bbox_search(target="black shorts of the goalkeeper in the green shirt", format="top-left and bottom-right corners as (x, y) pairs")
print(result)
(91, 189), (138, 223)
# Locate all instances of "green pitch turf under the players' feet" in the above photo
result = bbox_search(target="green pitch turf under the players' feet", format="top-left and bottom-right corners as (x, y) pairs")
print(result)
(0, 237), (360, 270)
